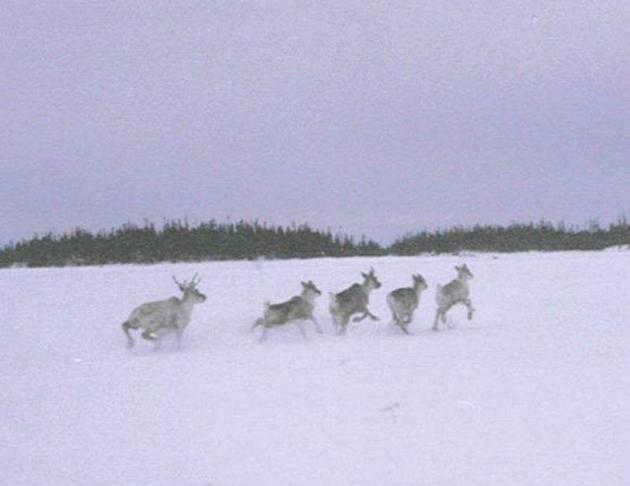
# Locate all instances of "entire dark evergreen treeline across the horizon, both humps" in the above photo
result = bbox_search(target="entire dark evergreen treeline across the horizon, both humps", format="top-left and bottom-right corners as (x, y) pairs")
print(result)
(0, 217), (630, 267)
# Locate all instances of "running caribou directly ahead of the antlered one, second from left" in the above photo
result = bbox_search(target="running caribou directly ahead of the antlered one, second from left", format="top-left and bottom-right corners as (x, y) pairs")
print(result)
(251, 280), (322, 341)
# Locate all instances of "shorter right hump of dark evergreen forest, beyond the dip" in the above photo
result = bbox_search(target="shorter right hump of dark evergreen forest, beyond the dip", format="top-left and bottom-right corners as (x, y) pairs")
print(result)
(388, 217), (630, 255)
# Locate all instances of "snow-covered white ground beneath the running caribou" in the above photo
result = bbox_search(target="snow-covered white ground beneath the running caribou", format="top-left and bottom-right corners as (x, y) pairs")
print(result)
(0, 251), (630, 486)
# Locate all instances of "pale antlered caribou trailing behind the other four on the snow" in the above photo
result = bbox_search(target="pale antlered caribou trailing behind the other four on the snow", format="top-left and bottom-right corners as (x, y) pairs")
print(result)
(122, 274), (206, 347)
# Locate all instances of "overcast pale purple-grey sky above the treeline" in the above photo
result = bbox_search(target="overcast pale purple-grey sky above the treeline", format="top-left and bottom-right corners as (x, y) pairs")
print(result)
(0, 0), (630, 243)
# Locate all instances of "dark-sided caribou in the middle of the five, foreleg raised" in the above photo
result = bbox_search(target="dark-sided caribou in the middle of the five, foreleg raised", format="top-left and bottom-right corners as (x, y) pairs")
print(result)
(328, 268), (381, 334)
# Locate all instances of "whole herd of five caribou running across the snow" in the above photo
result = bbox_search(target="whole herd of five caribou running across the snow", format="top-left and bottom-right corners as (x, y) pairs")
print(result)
(122, 264), (474, 347)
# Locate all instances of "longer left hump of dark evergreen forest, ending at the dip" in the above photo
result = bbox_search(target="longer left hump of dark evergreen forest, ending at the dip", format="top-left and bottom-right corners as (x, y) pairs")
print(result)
(0, 221), (383, 267)
